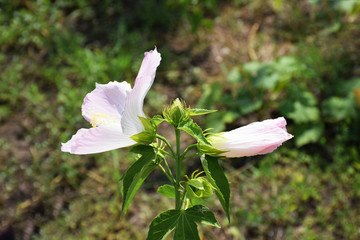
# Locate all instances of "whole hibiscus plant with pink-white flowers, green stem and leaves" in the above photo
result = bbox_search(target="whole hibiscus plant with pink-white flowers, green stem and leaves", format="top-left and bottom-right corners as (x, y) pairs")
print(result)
(61, 48), (292, 240)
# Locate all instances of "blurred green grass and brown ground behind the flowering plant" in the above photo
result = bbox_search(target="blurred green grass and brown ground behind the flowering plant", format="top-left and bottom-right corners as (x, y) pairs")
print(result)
(0, 0), (360, 240)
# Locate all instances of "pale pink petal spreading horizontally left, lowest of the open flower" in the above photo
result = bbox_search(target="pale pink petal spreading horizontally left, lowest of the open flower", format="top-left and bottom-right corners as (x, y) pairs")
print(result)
(61, 126), (136, 154)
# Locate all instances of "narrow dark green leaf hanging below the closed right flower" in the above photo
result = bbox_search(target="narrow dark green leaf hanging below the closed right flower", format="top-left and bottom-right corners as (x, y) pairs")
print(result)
(201, 155), (230, 221)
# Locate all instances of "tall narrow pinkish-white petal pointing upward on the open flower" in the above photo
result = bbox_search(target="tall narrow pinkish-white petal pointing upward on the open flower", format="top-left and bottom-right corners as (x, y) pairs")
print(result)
(121, 48), (161, 135)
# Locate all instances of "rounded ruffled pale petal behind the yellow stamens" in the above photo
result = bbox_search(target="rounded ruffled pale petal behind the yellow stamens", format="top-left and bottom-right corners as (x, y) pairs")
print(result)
(81, 81), (131, 126)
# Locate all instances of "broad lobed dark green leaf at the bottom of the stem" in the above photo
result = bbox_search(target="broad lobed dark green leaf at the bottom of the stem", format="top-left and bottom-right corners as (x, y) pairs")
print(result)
(146, 205), (220, 240)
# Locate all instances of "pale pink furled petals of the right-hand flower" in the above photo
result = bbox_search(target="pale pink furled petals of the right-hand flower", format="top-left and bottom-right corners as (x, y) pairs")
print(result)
(209, 117), (293, 157)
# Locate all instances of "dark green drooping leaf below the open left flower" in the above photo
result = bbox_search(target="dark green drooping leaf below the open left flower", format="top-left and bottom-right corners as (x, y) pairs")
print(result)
(121, 145), (157, 214)
